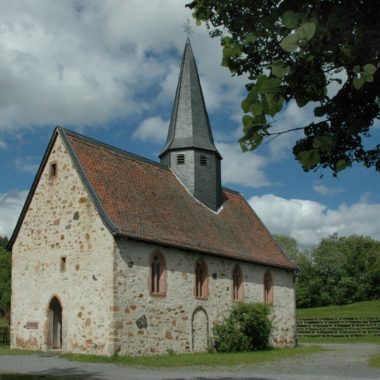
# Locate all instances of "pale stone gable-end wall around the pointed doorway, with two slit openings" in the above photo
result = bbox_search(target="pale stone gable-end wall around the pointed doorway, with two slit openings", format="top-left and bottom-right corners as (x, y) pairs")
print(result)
(11, 136), (114, 354)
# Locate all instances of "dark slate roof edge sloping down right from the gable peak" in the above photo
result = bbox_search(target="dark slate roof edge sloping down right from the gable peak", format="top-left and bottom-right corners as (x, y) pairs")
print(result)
(58, 128), (119, 235)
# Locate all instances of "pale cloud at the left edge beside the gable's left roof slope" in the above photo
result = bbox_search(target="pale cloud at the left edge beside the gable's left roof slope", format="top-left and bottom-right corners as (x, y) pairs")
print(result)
(0, 191), (28, 237)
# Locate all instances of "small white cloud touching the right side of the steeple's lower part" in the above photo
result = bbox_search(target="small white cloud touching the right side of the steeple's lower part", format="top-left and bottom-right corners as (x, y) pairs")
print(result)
(216, 143), (270, 188)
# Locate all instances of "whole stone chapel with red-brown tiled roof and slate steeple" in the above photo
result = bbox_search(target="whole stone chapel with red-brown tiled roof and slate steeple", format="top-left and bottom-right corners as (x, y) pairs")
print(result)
(8, 40), (297, 355)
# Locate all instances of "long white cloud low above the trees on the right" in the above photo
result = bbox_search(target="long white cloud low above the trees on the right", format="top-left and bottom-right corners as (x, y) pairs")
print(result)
(249, 194), (380, 247)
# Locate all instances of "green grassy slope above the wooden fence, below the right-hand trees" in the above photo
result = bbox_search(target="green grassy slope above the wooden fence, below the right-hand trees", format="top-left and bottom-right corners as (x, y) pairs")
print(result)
(297, 300), (380, 318)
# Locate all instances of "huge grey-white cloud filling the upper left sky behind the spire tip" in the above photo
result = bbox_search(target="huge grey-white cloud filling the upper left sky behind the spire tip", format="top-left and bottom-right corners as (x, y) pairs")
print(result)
(0, 0), (241, 135)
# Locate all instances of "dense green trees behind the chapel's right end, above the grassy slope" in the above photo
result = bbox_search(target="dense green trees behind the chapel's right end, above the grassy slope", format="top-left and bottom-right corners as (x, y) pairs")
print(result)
(297, 234), (380, 307)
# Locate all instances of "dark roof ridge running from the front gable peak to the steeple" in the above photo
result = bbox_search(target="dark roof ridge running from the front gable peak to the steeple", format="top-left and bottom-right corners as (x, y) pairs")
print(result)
(58, 127), (169, 171)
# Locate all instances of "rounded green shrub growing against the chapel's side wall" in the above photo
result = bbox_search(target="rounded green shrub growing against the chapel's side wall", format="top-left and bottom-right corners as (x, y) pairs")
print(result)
(213, 303), (272, 352)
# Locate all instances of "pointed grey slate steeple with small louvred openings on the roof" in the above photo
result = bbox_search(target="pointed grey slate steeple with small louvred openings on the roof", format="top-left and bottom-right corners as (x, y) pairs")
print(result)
(160, 39), (222, 211)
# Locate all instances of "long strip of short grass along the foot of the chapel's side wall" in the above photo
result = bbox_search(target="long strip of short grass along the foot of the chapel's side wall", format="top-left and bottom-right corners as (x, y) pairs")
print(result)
(62, 346), (326, 368)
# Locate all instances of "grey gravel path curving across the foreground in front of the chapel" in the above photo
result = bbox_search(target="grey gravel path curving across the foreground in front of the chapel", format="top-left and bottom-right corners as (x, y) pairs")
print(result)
(0, 344), (380, 380)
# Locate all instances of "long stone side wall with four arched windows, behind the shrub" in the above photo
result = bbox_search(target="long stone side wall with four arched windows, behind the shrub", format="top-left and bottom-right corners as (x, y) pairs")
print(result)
(115, 240), (295, 355)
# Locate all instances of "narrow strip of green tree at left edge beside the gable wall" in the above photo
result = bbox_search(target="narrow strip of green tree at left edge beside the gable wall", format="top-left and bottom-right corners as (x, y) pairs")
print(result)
(0, 236), (12, 315)
